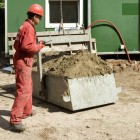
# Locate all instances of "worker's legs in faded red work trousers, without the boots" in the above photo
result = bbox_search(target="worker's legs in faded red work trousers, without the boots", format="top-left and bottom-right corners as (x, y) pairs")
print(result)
(10, 67), (32, 124)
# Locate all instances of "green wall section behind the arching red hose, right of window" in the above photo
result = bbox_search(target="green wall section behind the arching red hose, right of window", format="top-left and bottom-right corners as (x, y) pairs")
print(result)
(91, 0), (139, 52)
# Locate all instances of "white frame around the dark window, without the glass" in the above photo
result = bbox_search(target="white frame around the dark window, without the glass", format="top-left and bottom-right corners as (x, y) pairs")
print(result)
(45, 0), (83, 28)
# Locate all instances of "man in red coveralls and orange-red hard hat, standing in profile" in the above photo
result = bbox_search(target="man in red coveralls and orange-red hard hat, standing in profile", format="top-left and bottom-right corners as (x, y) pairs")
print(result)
(10, 4), (44, 132)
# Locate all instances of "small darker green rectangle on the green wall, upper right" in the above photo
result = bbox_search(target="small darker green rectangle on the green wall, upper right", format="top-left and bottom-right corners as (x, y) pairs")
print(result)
(122, 3), (138, 15)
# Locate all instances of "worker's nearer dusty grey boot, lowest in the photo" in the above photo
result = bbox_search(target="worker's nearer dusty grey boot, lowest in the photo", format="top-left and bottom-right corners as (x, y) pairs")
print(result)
(10, 123), (26, 132)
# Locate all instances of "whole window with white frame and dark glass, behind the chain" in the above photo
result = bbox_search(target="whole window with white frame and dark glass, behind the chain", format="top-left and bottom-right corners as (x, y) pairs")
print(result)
(45, 0), (83, 28)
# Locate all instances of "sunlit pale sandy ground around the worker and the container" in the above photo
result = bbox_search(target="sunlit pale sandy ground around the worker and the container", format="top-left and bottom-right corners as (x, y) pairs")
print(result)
(0, 61), (140, 140)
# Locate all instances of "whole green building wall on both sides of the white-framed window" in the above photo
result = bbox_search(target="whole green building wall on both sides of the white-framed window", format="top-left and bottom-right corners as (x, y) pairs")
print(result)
(8, 0), (139, 53)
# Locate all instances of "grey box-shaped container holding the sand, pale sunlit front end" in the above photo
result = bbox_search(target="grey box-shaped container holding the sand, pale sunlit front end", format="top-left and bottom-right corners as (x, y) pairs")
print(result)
(33, 73), (118, 111)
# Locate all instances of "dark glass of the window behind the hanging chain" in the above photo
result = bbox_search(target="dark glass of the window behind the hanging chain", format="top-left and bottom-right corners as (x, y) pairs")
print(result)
(50, 1), (78, 23)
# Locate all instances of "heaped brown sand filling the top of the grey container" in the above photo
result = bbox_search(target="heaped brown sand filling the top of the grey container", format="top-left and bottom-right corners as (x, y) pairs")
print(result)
(34, 51), (112, 78)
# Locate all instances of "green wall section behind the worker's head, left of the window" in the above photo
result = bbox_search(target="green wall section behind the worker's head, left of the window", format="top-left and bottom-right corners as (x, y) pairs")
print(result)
(7, 0), (45, 32)
